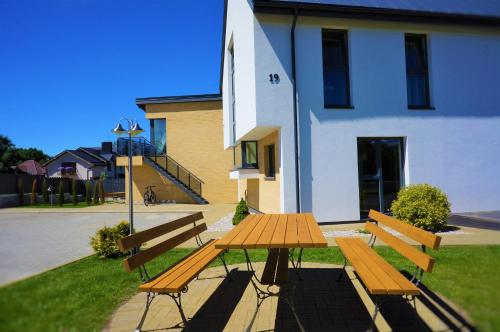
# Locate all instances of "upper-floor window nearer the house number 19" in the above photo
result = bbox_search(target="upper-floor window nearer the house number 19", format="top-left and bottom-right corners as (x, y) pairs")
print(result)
(323, 30), (351, 108)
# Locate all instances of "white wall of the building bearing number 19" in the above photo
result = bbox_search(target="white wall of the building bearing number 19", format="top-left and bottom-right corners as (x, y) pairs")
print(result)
(250, 14), (500, 221)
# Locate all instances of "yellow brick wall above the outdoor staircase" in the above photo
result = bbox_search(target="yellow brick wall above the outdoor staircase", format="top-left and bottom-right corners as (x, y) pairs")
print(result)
(146, 102), (238, 203)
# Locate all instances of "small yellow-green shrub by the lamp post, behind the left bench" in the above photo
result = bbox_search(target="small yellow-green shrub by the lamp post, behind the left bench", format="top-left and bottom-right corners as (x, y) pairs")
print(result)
(90, 221), (129, 258)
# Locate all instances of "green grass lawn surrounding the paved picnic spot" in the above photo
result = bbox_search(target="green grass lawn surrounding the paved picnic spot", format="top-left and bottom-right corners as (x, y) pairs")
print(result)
(0, 246), (500, 331)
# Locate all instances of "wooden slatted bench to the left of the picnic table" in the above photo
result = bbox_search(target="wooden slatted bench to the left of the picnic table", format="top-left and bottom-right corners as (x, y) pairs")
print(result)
(117, 212), (229, 331)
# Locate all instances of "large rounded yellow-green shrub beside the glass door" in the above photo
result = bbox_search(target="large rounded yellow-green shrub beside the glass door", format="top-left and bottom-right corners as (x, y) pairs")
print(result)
(391, 183), (451, 232)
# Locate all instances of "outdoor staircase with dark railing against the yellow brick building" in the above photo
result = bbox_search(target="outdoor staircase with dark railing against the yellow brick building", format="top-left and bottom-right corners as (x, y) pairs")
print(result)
(144, 156), (208, 204)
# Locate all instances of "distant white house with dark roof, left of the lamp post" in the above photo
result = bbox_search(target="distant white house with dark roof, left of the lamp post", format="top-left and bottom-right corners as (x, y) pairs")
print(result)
(44, 142), (124, 180)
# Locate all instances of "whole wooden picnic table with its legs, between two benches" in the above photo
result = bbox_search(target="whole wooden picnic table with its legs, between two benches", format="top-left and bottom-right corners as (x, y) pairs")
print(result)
(215, 213), (328, 331)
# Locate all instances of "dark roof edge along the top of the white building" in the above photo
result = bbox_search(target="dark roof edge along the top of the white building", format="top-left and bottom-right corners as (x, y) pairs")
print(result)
(254, 0), (500, 26)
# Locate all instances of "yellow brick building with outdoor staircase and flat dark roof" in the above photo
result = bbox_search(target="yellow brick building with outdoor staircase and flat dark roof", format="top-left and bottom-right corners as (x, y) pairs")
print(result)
(118, 95), (237, 204)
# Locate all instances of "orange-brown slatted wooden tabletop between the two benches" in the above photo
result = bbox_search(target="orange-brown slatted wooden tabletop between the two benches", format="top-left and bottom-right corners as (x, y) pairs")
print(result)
(215, 213), (327, 249)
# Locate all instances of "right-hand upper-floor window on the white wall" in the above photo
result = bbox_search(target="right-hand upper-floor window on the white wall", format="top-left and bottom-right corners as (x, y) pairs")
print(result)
(405, 34), (430, 109)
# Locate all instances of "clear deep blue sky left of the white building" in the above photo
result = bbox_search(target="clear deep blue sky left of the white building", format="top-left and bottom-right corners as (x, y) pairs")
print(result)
(0, 0), (223, 155)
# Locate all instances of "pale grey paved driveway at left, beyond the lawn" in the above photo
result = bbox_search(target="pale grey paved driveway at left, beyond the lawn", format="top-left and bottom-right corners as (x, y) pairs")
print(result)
(0, 212), (189, 285)
